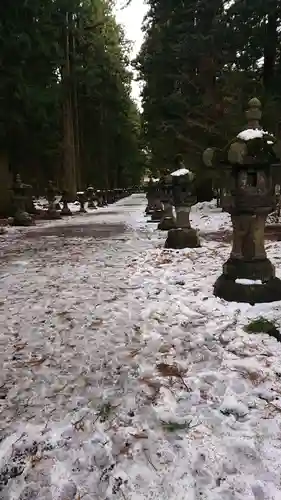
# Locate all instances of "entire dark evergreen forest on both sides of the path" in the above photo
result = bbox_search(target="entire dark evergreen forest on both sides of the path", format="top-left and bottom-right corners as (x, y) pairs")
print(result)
(0, 0), (281, 210)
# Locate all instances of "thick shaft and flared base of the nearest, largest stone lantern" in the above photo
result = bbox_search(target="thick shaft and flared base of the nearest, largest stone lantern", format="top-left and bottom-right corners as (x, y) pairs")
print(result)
(214, 213), (281, 304)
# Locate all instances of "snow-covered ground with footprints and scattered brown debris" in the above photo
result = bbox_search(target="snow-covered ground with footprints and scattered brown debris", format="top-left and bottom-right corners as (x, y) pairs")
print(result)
(0, 195), (281, 500)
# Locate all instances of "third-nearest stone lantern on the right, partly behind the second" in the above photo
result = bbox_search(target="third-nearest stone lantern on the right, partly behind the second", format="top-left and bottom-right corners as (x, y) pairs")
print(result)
(158, 174), (176, 231)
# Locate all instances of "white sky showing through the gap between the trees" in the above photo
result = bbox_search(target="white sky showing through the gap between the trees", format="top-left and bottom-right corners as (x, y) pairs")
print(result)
(116, 0), (147, 105)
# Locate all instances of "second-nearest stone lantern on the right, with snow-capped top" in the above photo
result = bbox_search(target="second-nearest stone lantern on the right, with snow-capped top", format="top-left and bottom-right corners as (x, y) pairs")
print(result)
(165, 168), (200, 249)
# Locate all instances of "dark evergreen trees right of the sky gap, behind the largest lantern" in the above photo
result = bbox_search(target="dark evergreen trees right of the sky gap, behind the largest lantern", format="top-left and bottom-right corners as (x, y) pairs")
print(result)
(135, 0), (281, 178)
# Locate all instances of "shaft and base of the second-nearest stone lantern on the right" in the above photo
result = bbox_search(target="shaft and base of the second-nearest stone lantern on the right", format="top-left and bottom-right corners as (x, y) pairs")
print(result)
(165, 206), (201, 249)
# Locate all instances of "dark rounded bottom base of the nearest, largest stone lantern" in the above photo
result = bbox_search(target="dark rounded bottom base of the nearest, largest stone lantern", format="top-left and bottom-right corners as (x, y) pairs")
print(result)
(214, 274), (281, 305)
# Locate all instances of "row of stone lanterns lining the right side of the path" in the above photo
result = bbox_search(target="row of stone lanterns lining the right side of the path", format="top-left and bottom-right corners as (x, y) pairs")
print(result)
(147, 98), (281, 304)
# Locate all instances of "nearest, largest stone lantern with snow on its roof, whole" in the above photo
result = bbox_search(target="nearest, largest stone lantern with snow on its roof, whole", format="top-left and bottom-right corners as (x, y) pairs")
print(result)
(203, 98), (281, 304)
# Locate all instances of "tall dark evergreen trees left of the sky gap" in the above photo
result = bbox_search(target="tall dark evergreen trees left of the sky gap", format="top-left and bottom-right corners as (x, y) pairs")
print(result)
(0, 0), (144, 209)
